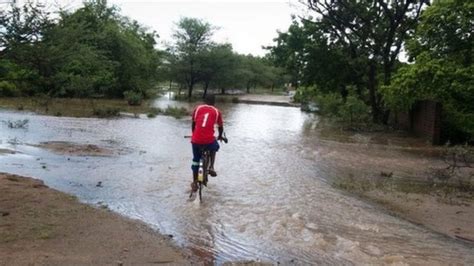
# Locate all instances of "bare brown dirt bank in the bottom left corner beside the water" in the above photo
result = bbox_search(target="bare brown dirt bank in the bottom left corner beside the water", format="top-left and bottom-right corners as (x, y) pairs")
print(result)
(0, 173), (188, 265)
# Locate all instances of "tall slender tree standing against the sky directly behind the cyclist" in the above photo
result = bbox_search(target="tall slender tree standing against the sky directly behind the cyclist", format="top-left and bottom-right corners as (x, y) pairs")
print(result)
(173, 18), (215, 98)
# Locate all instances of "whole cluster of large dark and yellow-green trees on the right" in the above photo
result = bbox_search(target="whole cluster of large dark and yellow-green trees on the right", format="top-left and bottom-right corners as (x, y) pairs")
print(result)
(268, 0), (474, 142)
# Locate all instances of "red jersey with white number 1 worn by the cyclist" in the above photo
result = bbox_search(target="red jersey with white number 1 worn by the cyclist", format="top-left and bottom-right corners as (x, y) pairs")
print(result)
(191, 104), (224, 144)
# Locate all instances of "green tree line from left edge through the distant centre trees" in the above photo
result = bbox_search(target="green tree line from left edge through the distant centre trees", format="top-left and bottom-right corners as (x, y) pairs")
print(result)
(0, 0), (284, 102)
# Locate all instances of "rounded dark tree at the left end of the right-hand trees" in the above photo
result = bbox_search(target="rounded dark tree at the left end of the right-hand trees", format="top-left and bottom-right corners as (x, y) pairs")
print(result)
(267, 18), (365, 97)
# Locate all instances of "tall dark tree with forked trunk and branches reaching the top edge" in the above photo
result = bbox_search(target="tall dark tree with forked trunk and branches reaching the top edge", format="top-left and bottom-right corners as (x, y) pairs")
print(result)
(303, 0), (429, 122)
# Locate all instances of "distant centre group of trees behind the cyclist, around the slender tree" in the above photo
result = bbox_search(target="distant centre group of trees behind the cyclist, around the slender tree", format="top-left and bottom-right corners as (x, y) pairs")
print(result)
(164, 18), (286, 97)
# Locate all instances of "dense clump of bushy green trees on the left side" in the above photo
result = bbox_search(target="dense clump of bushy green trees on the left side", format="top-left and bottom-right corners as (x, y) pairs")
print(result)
(0, 0), (161, 97)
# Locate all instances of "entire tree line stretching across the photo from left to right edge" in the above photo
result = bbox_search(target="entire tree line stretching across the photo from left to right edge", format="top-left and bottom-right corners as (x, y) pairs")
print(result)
(0, 0), (474, 142)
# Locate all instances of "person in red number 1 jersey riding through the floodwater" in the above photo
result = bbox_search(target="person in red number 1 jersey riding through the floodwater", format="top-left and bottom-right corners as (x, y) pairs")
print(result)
(191, 94), (224, 192)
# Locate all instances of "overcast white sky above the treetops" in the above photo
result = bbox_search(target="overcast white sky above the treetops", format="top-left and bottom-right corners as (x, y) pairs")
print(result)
(6, 0), (297, 55)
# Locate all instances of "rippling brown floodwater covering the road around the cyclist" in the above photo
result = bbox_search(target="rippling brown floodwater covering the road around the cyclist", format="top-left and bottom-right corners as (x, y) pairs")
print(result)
(0, 102), (474, 265)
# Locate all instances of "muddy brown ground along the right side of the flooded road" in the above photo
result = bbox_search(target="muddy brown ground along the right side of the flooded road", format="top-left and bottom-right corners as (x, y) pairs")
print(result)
(315, 134), (474, 244)
